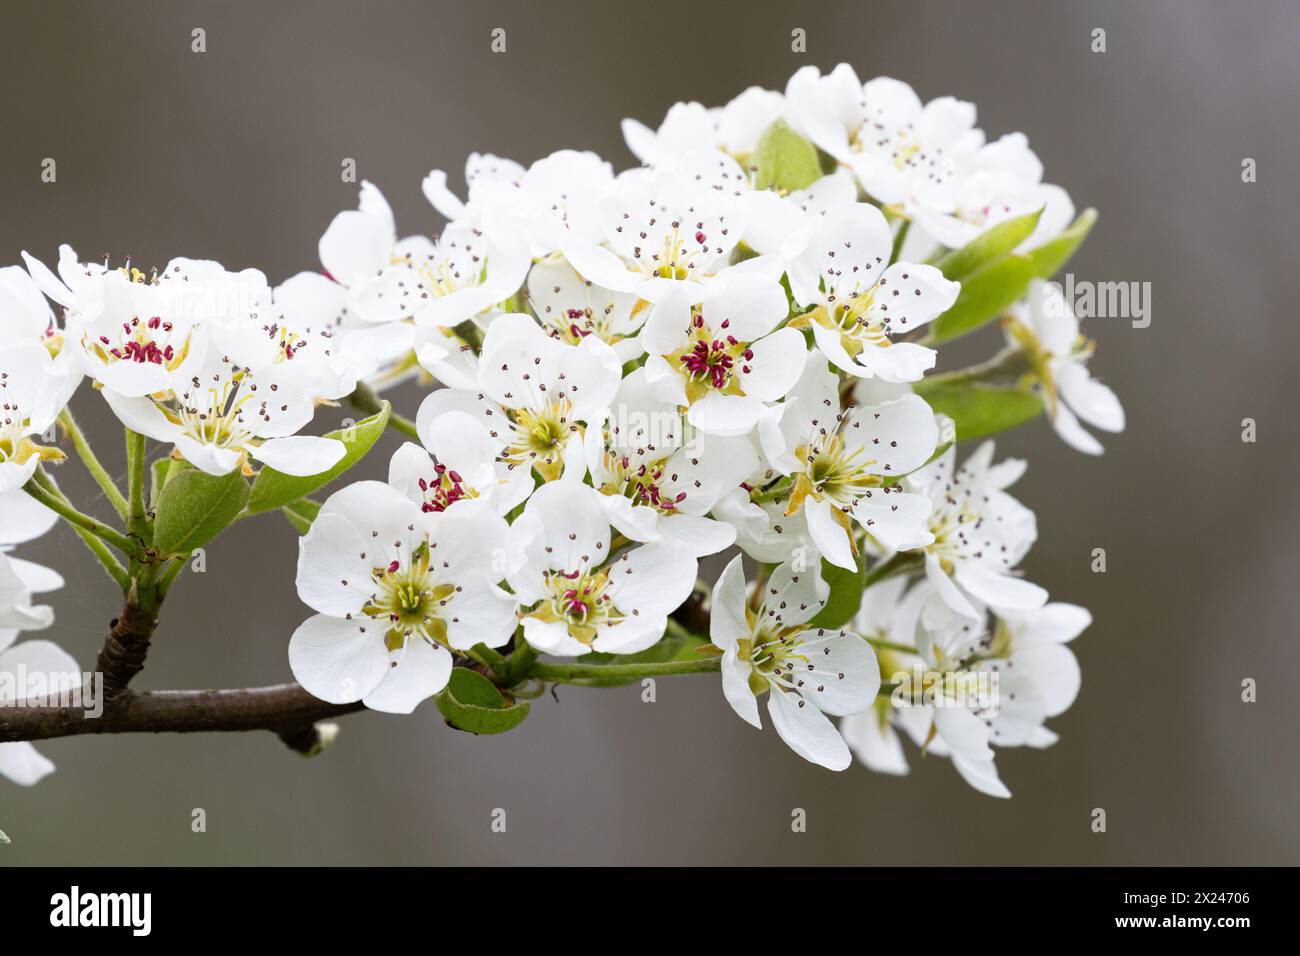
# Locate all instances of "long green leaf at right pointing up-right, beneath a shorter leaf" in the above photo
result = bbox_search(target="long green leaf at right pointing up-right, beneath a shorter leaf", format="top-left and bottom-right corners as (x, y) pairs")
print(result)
(927, 209), (1097, 345)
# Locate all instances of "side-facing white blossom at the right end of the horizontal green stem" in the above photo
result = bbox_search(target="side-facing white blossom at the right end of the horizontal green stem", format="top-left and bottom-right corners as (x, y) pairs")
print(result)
(709, 557), (880, 770)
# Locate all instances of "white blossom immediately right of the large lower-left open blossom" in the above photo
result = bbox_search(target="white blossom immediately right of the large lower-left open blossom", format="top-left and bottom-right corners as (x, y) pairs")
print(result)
(507, 481), (697, 657)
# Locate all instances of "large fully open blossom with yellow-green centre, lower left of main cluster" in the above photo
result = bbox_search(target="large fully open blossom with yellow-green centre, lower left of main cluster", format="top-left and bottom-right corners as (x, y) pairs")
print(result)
(289, 481), (515, 714)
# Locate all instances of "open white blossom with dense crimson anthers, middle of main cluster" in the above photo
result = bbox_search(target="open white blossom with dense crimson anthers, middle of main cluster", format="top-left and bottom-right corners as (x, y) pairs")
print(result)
(641, 274), (806, 436)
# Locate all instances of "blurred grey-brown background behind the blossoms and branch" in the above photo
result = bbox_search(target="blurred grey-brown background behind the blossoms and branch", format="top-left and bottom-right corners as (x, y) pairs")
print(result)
(0, 0), (1300, 865)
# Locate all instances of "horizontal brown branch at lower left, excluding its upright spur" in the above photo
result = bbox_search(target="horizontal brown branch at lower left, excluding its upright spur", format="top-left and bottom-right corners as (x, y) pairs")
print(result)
(0, 683), (365, 753)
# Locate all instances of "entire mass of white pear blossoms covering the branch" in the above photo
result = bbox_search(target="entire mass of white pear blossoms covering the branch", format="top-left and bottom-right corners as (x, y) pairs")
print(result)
(0, 65), (1123, 795)
